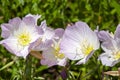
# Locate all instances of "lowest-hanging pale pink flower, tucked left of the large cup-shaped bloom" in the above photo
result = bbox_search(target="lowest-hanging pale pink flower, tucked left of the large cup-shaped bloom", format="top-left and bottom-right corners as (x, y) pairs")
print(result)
(41, 29), (66, 67)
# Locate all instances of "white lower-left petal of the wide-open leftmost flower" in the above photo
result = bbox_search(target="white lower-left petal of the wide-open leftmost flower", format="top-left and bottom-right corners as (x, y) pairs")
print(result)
(0, 38), (29, 58)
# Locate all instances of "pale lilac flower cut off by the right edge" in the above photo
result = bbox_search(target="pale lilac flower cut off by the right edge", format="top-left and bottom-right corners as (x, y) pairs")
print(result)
(98, 25), (120, 67)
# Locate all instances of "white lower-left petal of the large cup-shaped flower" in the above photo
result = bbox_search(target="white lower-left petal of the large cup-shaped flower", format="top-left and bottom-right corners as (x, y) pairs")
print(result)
(60, 36), (81, 60)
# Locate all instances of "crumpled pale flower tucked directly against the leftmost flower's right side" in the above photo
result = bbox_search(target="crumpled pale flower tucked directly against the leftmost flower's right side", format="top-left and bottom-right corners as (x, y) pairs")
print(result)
(31, 21), (55, 51)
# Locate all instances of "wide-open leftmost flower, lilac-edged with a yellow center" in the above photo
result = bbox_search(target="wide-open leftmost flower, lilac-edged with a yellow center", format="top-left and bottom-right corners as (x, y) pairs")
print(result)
(0, 14), (41, 58)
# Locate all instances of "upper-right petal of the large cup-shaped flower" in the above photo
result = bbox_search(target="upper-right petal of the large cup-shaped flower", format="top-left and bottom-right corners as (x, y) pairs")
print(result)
(75, 22), (99, 50)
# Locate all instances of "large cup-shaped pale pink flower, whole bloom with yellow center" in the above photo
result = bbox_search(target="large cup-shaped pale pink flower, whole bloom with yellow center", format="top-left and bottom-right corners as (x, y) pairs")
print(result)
(60, 21), (99, 64)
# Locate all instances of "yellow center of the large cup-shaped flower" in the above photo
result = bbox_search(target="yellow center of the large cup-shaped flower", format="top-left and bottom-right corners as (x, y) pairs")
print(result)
(81, 40), (94, 55)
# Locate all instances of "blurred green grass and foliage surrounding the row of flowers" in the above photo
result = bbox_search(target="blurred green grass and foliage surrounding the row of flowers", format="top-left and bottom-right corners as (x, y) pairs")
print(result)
(0, 0), (120, 80)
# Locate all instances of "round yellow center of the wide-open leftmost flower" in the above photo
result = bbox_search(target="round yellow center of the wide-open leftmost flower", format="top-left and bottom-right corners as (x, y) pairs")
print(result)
(18, 33), (31, 46)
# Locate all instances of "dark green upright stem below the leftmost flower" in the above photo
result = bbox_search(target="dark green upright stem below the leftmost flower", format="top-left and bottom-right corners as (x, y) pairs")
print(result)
(24, 55), (32, 80)
